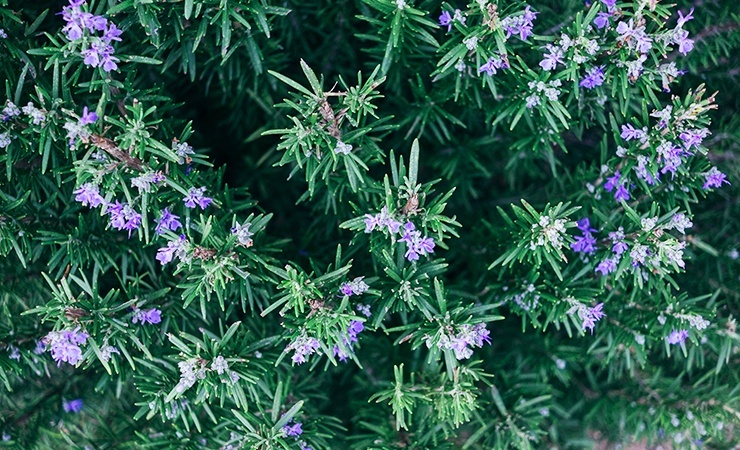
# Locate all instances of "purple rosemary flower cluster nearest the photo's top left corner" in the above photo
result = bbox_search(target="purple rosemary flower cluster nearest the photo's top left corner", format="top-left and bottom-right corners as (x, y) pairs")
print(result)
(62, 0), (122, 72)
